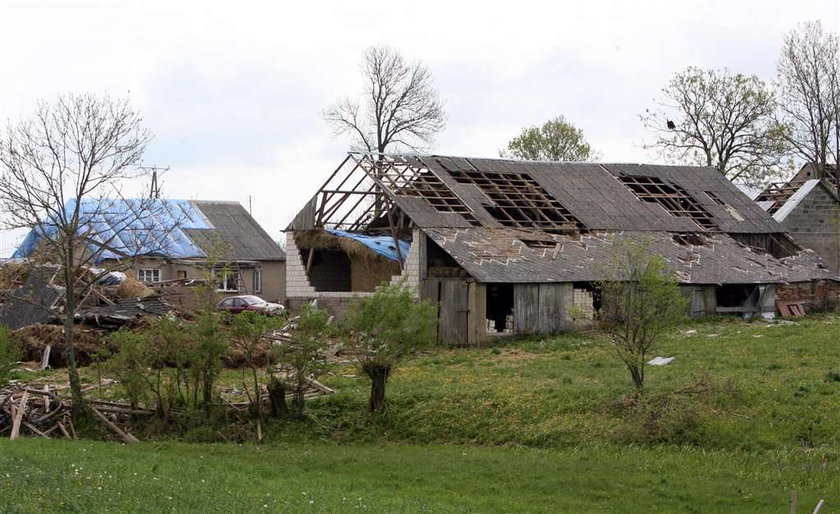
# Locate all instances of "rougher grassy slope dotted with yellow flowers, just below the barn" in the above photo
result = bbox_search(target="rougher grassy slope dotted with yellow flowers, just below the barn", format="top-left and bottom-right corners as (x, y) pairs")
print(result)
(288, 317), (840, 450)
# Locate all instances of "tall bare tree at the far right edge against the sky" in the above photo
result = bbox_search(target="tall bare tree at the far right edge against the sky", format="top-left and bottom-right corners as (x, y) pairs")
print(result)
(777, 21), (840, 191)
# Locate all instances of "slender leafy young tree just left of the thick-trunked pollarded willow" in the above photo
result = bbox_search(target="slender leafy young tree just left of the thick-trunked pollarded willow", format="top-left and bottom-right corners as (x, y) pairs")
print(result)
(281, 303), (333, 417)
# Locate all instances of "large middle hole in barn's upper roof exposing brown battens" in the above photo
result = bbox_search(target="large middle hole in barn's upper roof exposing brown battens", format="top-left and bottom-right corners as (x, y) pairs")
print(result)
(449, 170), (586, 233)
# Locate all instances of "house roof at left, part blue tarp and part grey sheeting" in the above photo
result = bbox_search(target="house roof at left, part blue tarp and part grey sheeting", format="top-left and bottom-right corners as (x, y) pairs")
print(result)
(13, 198), (285, 262)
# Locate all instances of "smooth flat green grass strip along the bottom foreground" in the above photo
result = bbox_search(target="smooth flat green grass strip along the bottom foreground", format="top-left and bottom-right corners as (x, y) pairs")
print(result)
(0, 439), (840, 513)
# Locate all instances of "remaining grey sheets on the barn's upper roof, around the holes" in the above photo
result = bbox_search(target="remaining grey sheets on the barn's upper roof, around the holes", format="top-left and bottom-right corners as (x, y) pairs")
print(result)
(406, 156), (784, 233)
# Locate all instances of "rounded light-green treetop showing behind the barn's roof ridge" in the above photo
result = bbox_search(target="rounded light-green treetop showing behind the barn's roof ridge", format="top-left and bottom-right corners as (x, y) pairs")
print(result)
(500, 116), (598, 161)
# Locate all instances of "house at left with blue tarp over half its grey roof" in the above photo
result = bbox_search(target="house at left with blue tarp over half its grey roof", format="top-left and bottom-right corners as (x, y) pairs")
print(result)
(13, 198), (286, 301)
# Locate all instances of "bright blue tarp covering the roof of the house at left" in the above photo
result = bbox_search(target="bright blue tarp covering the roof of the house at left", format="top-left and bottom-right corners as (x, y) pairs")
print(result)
(12, 198), (213, 262)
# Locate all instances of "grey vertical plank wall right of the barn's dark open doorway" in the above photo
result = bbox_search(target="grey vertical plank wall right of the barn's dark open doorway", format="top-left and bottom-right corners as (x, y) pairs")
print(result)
(513, 283), (574, 334)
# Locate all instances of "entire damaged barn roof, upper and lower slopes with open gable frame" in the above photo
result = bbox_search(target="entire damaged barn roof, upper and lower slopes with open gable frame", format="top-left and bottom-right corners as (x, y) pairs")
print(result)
(288, 154), (834, 284)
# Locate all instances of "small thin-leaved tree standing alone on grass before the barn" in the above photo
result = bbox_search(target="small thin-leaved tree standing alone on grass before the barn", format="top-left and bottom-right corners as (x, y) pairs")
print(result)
(599, 239), (688, 392)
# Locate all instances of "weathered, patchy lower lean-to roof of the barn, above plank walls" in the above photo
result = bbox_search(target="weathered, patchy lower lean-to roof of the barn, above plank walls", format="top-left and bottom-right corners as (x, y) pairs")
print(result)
(424, 227), (837, 284)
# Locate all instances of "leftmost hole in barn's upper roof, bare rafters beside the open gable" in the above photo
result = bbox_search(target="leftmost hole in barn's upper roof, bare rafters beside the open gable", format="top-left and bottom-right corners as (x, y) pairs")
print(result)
(374, 159), (478, 222)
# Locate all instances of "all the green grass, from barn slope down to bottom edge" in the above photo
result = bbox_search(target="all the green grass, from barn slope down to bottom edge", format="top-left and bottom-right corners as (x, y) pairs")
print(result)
(6, 316), (840, 512)
